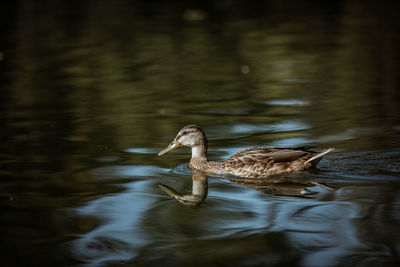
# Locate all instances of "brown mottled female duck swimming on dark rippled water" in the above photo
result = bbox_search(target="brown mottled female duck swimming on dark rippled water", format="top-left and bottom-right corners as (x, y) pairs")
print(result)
(158, 125), (333, 178)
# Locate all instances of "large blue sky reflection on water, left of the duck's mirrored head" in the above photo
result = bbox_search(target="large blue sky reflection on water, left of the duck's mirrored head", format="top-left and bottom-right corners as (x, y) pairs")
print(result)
(72, 181), (155, 266)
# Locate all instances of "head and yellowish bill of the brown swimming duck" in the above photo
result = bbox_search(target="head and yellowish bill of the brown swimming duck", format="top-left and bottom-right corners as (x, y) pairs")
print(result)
(158, 125), (207, 156)
